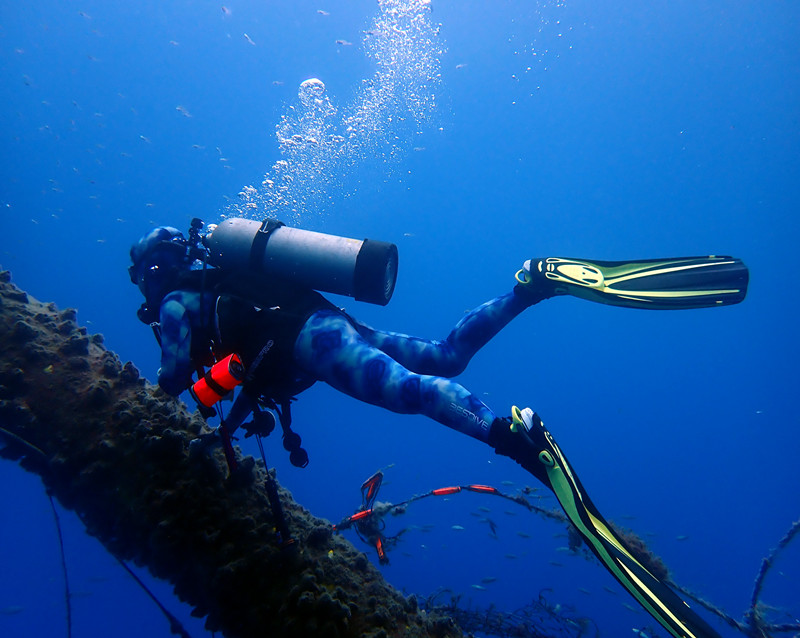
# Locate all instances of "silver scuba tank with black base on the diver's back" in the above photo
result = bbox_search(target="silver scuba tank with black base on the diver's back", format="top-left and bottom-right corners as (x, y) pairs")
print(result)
(203, 217), (398, 306)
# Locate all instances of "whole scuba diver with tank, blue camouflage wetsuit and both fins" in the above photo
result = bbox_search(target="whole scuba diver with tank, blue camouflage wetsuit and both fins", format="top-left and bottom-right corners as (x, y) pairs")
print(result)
(129, 218), (749, 638)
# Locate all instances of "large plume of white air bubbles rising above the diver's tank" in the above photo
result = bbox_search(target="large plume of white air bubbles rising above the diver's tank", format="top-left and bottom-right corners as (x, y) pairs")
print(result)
(226, 0), (443, 223)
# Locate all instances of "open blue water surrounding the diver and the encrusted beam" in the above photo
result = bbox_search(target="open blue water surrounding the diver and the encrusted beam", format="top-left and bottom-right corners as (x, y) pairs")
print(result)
(0, 0), (800, 637)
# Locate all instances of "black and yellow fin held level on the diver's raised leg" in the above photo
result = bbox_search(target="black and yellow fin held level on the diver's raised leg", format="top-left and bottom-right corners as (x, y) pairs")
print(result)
(516, 255), (749, 310)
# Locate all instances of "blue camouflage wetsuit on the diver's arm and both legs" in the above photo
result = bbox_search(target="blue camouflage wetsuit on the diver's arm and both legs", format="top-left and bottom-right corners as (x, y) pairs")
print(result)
(158, 290), (538, 442)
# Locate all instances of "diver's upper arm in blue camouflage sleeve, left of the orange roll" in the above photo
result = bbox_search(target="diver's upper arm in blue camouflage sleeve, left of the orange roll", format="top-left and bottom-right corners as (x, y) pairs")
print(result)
(158, 297), (193, 396)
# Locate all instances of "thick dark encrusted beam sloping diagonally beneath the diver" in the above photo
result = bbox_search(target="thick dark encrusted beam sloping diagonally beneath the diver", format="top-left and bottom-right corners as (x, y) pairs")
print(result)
(0, 272), (462, 637)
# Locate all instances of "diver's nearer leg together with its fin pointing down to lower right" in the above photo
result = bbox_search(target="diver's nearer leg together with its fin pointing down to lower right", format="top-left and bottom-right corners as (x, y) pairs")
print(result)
(302, 318), (719, 638)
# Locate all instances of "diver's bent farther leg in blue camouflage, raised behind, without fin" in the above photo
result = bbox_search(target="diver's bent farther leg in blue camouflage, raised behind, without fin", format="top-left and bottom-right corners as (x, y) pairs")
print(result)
(353, 286), (543, 377)
